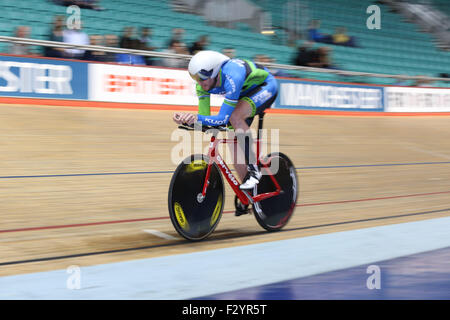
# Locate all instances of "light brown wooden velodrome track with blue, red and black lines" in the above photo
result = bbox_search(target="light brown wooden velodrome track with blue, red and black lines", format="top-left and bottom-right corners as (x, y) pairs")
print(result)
(0, 105), (450, 276)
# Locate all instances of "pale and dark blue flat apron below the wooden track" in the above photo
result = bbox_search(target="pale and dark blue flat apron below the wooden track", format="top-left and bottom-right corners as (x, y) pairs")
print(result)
(0, 217), (450, 300)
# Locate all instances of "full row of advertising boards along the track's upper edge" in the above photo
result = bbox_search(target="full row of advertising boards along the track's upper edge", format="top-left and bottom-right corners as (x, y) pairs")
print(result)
(0, 55), (450, 114)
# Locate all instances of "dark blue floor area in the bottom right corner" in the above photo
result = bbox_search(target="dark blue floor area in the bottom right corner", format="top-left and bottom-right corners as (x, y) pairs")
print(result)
(198, 247), (450, 300)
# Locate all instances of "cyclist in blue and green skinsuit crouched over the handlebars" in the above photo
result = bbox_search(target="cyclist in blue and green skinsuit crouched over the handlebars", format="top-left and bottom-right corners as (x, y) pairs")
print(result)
(173, 50), (278, 195)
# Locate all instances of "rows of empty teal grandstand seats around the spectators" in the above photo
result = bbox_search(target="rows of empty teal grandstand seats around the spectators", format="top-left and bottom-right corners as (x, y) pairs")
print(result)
(0, 0), (450, 83)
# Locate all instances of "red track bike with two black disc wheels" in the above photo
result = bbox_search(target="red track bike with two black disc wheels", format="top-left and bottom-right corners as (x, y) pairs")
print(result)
(168, 113), (298, 241)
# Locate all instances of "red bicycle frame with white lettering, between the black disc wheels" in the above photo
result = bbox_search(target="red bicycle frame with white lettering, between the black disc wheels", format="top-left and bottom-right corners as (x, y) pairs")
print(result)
(202, 130), (281, 205)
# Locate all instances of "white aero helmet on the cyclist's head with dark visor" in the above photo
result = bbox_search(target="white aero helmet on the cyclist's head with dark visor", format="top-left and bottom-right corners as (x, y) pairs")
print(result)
(188, 50), (230, 82)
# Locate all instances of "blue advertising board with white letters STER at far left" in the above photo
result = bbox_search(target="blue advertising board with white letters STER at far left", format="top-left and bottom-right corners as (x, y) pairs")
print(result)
(0, 56), (88, 100)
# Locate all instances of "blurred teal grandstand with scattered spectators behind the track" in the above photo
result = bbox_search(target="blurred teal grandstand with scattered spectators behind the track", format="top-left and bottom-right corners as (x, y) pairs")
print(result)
(0, 0), (450, 87)
